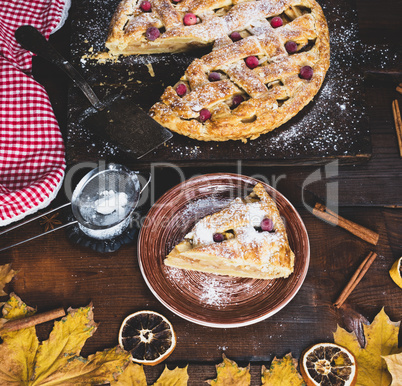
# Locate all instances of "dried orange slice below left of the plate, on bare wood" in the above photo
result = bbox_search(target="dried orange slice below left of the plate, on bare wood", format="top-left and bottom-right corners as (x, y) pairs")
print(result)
(119, 311), (176, 366)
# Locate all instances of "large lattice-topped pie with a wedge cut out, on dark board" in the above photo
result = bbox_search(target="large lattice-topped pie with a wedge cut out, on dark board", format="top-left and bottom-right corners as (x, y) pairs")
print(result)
(106, 0), (329, 141)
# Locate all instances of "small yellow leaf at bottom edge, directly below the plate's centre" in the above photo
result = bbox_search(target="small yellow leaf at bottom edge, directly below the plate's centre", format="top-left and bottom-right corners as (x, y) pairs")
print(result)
(207, 354), (251, 386)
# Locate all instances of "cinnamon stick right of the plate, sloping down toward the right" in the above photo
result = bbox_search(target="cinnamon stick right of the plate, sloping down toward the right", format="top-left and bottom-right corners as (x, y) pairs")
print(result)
(313, 202), (380, 245)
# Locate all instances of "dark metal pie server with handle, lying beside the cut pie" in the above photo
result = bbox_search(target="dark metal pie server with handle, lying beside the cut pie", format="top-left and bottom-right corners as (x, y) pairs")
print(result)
(15, 25), (173, 158)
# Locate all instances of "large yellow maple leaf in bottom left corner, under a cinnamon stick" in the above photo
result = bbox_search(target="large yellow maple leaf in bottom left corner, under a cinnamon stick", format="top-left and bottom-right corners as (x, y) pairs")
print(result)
(0, 294), (130, 386)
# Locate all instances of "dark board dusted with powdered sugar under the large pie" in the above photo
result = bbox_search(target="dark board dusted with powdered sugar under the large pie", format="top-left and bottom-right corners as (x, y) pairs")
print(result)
(67, 0), (385, 166)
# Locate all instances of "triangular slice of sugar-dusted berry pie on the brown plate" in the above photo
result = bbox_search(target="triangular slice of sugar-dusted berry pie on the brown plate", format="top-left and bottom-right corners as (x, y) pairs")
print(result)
(164, 183), (294, 279)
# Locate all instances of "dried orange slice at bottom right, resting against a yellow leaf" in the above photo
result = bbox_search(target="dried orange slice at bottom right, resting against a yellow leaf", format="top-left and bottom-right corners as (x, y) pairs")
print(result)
(300, 343), (357, 386)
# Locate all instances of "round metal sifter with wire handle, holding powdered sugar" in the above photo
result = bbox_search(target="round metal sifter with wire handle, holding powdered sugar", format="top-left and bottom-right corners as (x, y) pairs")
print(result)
(0, 163), (151, 252)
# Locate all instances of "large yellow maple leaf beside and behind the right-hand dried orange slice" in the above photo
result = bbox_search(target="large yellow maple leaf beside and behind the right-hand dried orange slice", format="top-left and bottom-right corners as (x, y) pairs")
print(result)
(334, 309), (400, 386)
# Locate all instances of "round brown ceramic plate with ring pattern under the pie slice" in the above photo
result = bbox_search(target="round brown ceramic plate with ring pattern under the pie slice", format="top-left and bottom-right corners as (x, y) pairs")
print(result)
(138, 173), (310, 327)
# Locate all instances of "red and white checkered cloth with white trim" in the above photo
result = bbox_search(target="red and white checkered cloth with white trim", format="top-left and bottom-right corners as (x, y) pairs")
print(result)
(0, 0), (69, 226)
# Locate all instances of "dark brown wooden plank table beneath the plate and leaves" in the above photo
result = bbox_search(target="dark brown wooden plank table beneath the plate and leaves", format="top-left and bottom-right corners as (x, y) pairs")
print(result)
(0, 0), (402, 385)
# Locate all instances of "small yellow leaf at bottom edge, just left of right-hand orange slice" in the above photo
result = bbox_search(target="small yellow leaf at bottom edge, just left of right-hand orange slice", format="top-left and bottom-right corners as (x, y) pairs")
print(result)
(261, 353), (305, 386)
